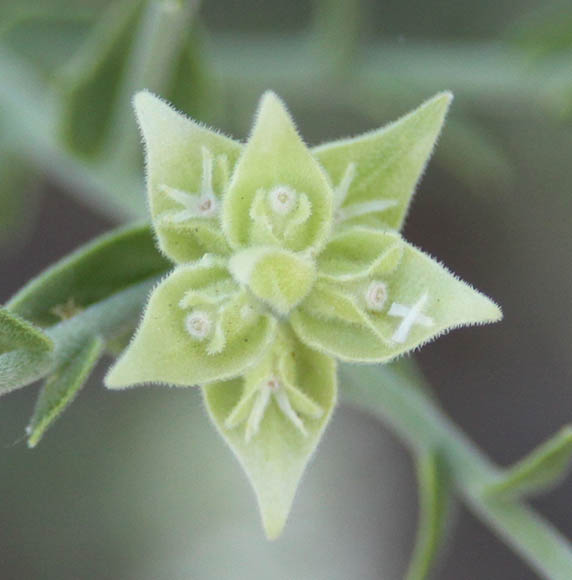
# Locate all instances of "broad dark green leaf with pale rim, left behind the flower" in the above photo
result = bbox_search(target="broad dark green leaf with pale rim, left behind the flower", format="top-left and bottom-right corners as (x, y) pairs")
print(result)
(7, 225), (171, 326)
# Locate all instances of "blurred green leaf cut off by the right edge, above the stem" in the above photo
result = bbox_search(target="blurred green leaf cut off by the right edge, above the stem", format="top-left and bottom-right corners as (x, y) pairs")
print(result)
(485, 426), (572, 498)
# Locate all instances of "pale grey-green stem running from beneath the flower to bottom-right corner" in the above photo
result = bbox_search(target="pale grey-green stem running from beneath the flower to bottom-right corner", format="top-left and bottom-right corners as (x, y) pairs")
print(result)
(341, 366), (572, 580)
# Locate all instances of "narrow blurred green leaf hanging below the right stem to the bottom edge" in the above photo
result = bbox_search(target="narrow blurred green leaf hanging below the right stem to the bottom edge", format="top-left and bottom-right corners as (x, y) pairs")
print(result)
(406, 449), (451, 580)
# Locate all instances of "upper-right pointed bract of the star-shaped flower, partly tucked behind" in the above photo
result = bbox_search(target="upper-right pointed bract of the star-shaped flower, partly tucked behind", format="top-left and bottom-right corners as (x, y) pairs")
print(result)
(312, 93), (452, 230)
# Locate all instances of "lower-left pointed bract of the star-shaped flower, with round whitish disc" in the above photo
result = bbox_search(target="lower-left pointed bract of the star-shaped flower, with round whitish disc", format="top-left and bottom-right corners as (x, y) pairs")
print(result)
(106, 256), (275, 388)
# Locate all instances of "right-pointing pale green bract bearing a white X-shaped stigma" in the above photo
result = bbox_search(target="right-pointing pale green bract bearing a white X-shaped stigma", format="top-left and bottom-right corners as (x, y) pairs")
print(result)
(290, 227), (502, 362)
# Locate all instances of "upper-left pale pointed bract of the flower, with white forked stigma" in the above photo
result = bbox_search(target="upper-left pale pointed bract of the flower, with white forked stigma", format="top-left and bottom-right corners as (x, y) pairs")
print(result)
(135, 92), (241, 263)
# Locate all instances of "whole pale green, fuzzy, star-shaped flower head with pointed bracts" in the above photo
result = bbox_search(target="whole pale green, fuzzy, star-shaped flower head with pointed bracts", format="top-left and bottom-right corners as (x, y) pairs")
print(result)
(106, 93), (501, 537)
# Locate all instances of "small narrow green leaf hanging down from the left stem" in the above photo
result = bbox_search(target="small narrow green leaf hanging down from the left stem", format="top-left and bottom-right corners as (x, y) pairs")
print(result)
(27, 336), (104, 447)
